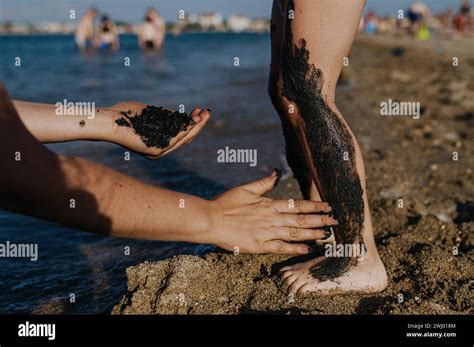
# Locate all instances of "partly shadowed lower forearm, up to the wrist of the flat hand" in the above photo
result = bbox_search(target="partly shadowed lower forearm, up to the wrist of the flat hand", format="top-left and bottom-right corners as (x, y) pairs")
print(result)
(0, 151), (212, 243)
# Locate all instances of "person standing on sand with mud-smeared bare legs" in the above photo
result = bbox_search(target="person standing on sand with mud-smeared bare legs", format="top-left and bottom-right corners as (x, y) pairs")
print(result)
(268, 0), (387, 294)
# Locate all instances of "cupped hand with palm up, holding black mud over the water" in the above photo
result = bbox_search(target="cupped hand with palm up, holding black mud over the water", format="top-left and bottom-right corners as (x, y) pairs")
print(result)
(107, 101), (211, 159)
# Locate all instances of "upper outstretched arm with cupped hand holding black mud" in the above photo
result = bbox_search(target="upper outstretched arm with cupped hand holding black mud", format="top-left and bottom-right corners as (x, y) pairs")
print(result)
(13, 100), (211, 159)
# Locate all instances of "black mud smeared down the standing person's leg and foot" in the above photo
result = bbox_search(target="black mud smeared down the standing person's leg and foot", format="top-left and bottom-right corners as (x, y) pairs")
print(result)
(281, 1), (364, 281)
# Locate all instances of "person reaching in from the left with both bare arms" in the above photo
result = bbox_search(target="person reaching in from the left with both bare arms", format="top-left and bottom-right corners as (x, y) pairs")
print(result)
(0, 83), (336, 254)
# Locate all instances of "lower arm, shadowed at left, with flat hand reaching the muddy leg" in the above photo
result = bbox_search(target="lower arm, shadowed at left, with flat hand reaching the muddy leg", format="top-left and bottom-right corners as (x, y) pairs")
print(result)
(0, 85), (336, 254)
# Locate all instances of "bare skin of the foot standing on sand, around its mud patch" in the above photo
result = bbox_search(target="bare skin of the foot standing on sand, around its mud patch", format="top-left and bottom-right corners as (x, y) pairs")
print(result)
(280, 256), (387, 295)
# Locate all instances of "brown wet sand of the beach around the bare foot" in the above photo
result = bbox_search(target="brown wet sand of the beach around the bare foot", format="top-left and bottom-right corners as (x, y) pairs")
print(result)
(112, 37), (474, 314)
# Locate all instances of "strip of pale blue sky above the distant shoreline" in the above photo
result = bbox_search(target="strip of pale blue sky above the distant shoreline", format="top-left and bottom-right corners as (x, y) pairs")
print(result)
(0, 0), (466, 23)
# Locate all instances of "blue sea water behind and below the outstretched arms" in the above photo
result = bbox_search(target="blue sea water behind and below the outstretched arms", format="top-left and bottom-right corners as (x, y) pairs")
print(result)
(0, 33), (285, 314)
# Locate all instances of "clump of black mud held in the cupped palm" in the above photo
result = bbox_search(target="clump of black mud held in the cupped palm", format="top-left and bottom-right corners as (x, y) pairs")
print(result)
(115, 105), (195, 148)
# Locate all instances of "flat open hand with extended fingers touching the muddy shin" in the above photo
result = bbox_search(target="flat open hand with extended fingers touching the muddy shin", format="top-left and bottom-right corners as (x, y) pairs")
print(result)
(210, 172), (338, 254)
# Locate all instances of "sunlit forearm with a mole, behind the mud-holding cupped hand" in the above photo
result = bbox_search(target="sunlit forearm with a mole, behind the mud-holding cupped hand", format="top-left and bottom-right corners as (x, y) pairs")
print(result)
(13, 100), (112, 143)
